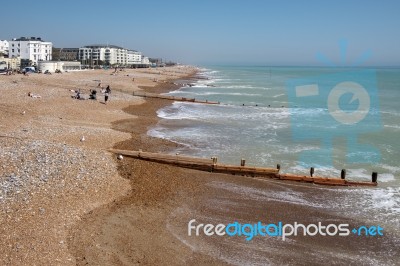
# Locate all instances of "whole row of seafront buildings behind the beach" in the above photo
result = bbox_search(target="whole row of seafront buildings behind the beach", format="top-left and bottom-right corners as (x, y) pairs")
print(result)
(0, 37), (151, 69)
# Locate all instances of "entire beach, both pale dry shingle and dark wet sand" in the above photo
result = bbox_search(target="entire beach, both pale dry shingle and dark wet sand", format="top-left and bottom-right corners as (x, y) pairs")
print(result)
(0, 68), (399, 265)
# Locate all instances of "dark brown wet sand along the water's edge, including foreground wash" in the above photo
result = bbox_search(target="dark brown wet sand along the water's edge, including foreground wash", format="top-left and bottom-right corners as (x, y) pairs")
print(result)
(68, 77), (399, 265)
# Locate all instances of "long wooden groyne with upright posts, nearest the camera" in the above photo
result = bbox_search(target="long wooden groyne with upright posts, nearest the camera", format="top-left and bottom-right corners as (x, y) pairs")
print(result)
(109, 149), (378, 186)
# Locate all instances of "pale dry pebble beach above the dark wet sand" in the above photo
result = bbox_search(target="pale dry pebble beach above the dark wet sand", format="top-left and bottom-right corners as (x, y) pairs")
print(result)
(0, 67), (197, 265)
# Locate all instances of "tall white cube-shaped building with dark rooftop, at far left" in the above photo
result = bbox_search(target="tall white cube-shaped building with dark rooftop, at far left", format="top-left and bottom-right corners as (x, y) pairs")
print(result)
(8, 37), (53, 64)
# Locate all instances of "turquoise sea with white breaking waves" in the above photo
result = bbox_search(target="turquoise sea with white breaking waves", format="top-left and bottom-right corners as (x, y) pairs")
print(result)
(148, 66), (400, 243)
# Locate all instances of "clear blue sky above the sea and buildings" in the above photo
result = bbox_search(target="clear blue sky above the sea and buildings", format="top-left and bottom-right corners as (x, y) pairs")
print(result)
(0, 0), (400, 66)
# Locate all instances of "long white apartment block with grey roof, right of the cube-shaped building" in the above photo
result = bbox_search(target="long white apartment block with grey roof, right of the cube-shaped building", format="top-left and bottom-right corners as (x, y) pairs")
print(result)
(78, 45), (128, 65)
